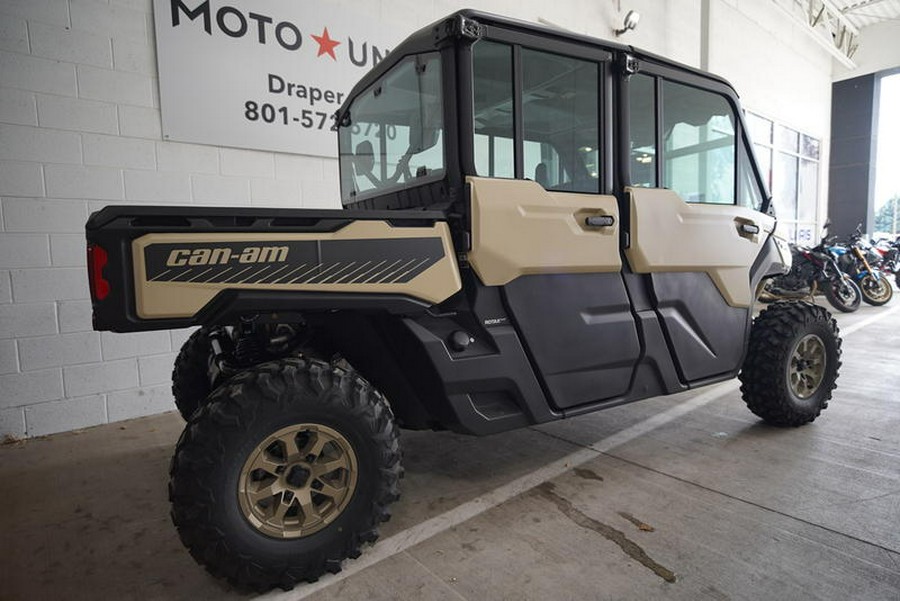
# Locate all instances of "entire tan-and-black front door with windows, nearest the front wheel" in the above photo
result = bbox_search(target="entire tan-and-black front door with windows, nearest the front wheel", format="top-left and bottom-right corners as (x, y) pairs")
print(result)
(620, 63), (775, 382)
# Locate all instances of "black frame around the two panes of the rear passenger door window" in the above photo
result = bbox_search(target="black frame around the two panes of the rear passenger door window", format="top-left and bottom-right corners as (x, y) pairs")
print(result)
(459, 27), (614, 195)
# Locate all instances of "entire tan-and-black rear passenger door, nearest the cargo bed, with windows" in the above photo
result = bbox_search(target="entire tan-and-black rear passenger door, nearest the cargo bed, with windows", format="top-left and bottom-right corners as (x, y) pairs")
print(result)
(467, 38), (641, 409)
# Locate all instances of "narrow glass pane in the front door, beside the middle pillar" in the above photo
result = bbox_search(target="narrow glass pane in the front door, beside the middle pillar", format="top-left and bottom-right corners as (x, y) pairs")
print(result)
(628, 73), (656, 188)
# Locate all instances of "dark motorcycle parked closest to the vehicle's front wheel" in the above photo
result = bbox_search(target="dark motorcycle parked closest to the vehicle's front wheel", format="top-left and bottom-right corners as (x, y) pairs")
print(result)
(760, 238), (862, 313)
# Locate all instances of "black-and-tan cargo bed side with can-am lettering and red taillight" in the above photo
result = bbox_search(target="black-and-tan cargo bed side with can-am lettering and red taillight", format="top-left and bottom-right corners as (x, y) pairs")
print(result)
(86, 206), (461, 332)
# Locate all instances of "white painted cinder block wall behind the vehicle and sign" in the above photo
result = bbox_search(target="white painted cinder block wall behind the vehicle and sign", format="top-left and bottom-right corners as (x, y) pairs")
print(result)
(0, 0), (830, 436)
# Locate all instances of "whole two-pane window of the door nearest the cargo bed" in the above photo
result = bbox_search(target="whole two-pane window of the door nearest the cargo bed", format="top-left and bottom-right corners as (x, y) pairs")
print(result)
(472, 40), (601, 193)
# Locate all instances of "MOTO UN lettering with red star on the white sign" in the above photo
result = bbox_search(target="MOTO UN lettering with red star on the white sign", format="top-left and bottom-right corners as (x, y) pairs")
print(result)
(170, 0), (389, 68)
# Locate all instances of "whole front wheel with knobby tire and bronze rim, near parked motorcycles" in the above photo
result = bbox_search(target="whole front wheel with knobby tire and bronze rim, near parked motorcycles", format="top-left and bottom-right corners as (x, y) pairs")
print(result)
(738, 301), (841, 427)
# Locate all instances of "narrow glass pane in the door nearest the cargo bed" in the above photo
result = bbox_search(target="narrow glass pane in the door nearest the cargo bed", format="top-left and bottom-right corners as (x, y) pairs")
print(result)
(472, 40), (515, 177)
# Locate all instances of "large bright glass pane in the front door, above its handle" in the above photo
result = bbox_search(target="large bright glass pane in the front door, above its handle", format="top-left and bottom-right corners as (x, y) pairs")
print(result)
(662, 81), (737, 204)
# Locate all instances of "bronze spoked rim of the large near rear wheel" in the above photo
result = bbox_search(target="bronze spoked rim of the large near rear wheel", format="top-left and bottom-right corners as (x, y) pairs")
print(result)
(238, 424), (358, 538)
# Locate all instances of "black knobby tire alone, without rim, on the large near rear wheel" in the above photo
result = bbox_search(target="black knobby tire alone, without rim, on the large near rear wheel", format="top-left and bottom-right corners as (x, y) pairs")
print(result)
(169, 358), (402, 592)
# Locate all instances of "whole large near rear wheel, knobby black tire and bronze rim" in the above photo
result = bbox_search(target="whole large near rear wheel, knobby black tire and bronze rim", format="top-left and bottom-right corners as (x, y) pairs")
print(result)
(169, 358), (402, 592)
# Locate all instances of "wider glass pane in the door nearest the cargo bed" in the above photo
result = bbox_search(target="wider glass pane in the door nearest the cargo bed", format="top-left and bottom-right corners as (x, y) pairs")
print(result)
(521, 48), (600, 193)
